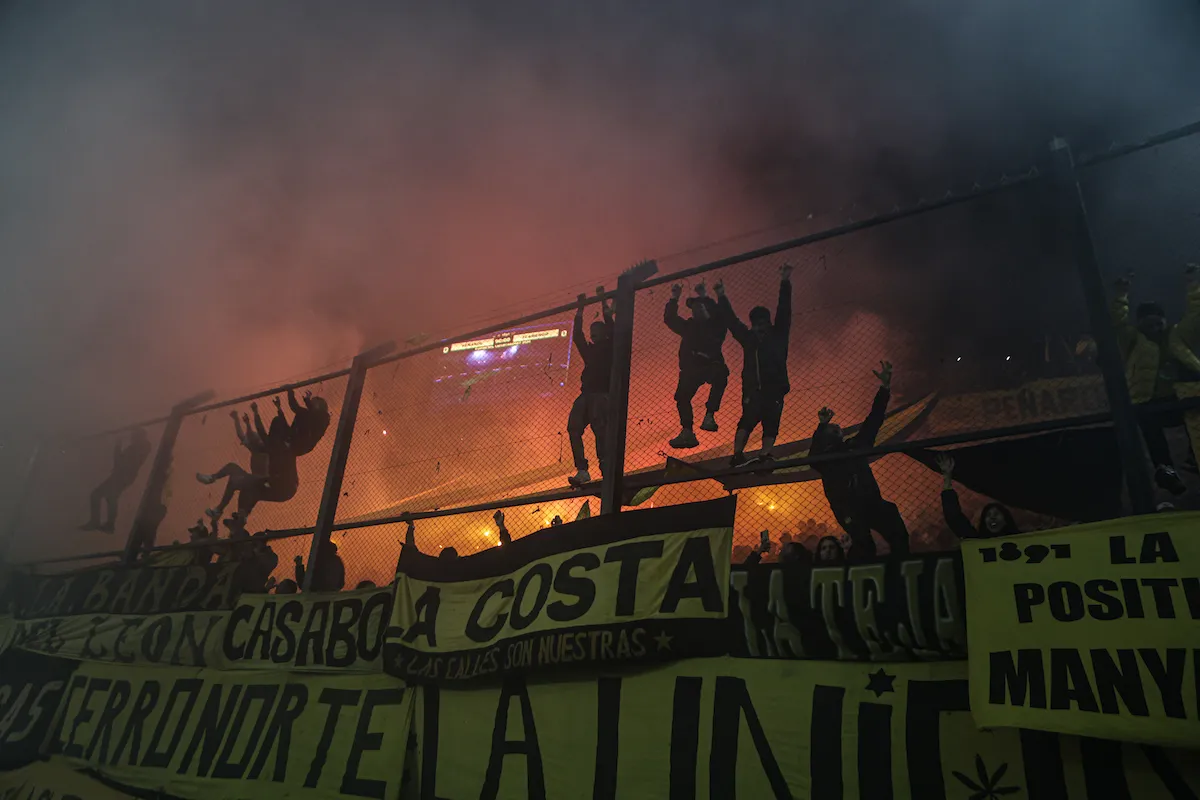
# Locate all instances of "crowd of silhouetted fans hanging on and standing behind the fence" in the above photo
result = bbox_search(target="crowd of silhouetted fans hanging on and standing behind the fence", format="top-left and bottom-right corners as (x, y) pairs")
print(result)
(105, 265), (1200, 594)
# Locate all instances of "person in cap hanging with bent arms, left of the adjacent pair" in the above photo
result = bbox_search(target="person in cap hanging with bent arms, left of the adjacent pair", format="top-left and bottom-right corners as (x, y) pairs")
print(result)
(662, 283), (730, 450)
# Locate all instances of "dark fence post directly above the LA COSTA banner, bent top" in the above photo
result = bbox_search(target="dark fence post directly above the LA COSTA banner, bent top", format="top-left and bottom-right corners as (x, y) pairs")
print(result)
(600, 261), (659, 513)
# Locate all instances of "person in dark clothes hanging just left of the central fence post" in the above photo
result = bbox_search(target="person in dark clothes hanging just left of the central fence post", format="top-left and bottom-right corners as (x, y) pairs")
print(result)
(566, 294), (612, 486)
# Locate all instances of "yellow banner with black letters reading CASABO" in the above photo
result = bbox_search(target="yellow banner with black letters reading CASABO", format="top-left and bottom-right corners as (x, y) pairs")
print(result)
(216, 587), (392, 673)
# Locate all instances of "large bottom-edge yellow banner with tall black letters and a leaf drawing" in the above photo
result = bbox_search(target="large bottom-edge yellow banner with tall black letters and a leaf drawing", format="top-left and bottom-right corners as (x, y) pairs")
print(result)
(418, 658), (1200, 800)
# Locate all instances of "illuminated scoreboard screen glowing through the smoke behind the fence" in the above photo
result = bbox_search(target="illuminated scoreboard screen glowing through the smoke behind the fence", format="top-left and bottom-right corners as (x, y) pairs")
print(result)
(433, 323), (571, 404)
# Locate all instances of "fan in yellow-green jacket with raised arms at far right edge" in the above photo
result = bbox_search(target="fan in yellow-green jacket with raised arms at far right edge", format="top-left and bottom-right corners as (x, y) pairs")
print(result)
(1111, 264), (1200, 494)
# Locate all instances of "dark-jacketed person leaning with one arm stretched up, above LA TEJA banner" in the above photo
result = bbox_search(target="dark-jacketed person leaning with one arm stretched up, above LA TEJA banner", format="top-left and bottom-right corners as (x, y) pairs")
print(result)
(809, 361), (908, 558)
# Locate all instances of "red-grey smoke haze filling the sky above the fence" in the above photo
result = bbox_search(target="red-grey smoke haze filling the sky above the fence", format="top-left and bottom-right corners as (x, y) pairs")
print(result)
(0, 0), (1200, 431)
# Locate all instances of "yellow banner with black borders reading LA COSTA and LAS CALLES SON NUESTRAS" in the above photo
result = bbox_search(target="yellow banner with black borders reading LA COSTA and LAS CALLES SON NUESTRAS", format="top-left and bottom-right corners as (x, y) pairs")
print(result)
(384, 498), (736, 681)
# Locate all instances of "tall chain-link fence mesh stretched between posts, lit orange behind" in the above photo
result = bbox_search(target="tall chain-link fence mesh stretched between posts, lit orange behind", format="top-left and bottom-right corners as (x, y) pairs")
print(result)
(11, 120), (1200, 588)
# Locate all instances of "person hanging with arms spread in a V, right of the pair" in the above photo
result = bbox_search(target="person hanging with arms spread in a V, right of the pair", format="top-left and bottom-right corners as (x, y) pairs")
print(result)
(713, 264), (792, 467)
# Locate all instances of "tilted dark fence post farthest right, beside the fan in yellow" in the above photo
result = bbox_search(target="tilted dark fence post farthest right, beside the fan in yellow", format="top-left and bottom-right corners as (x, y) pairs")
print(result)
(1050, 138), (1154, 513)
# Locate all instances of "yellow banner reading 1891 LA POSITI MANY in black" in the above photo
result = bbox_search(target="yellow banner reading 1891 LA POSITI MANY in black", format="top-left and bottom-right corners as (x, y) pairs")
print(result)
(962, 512), (1200, 747)
